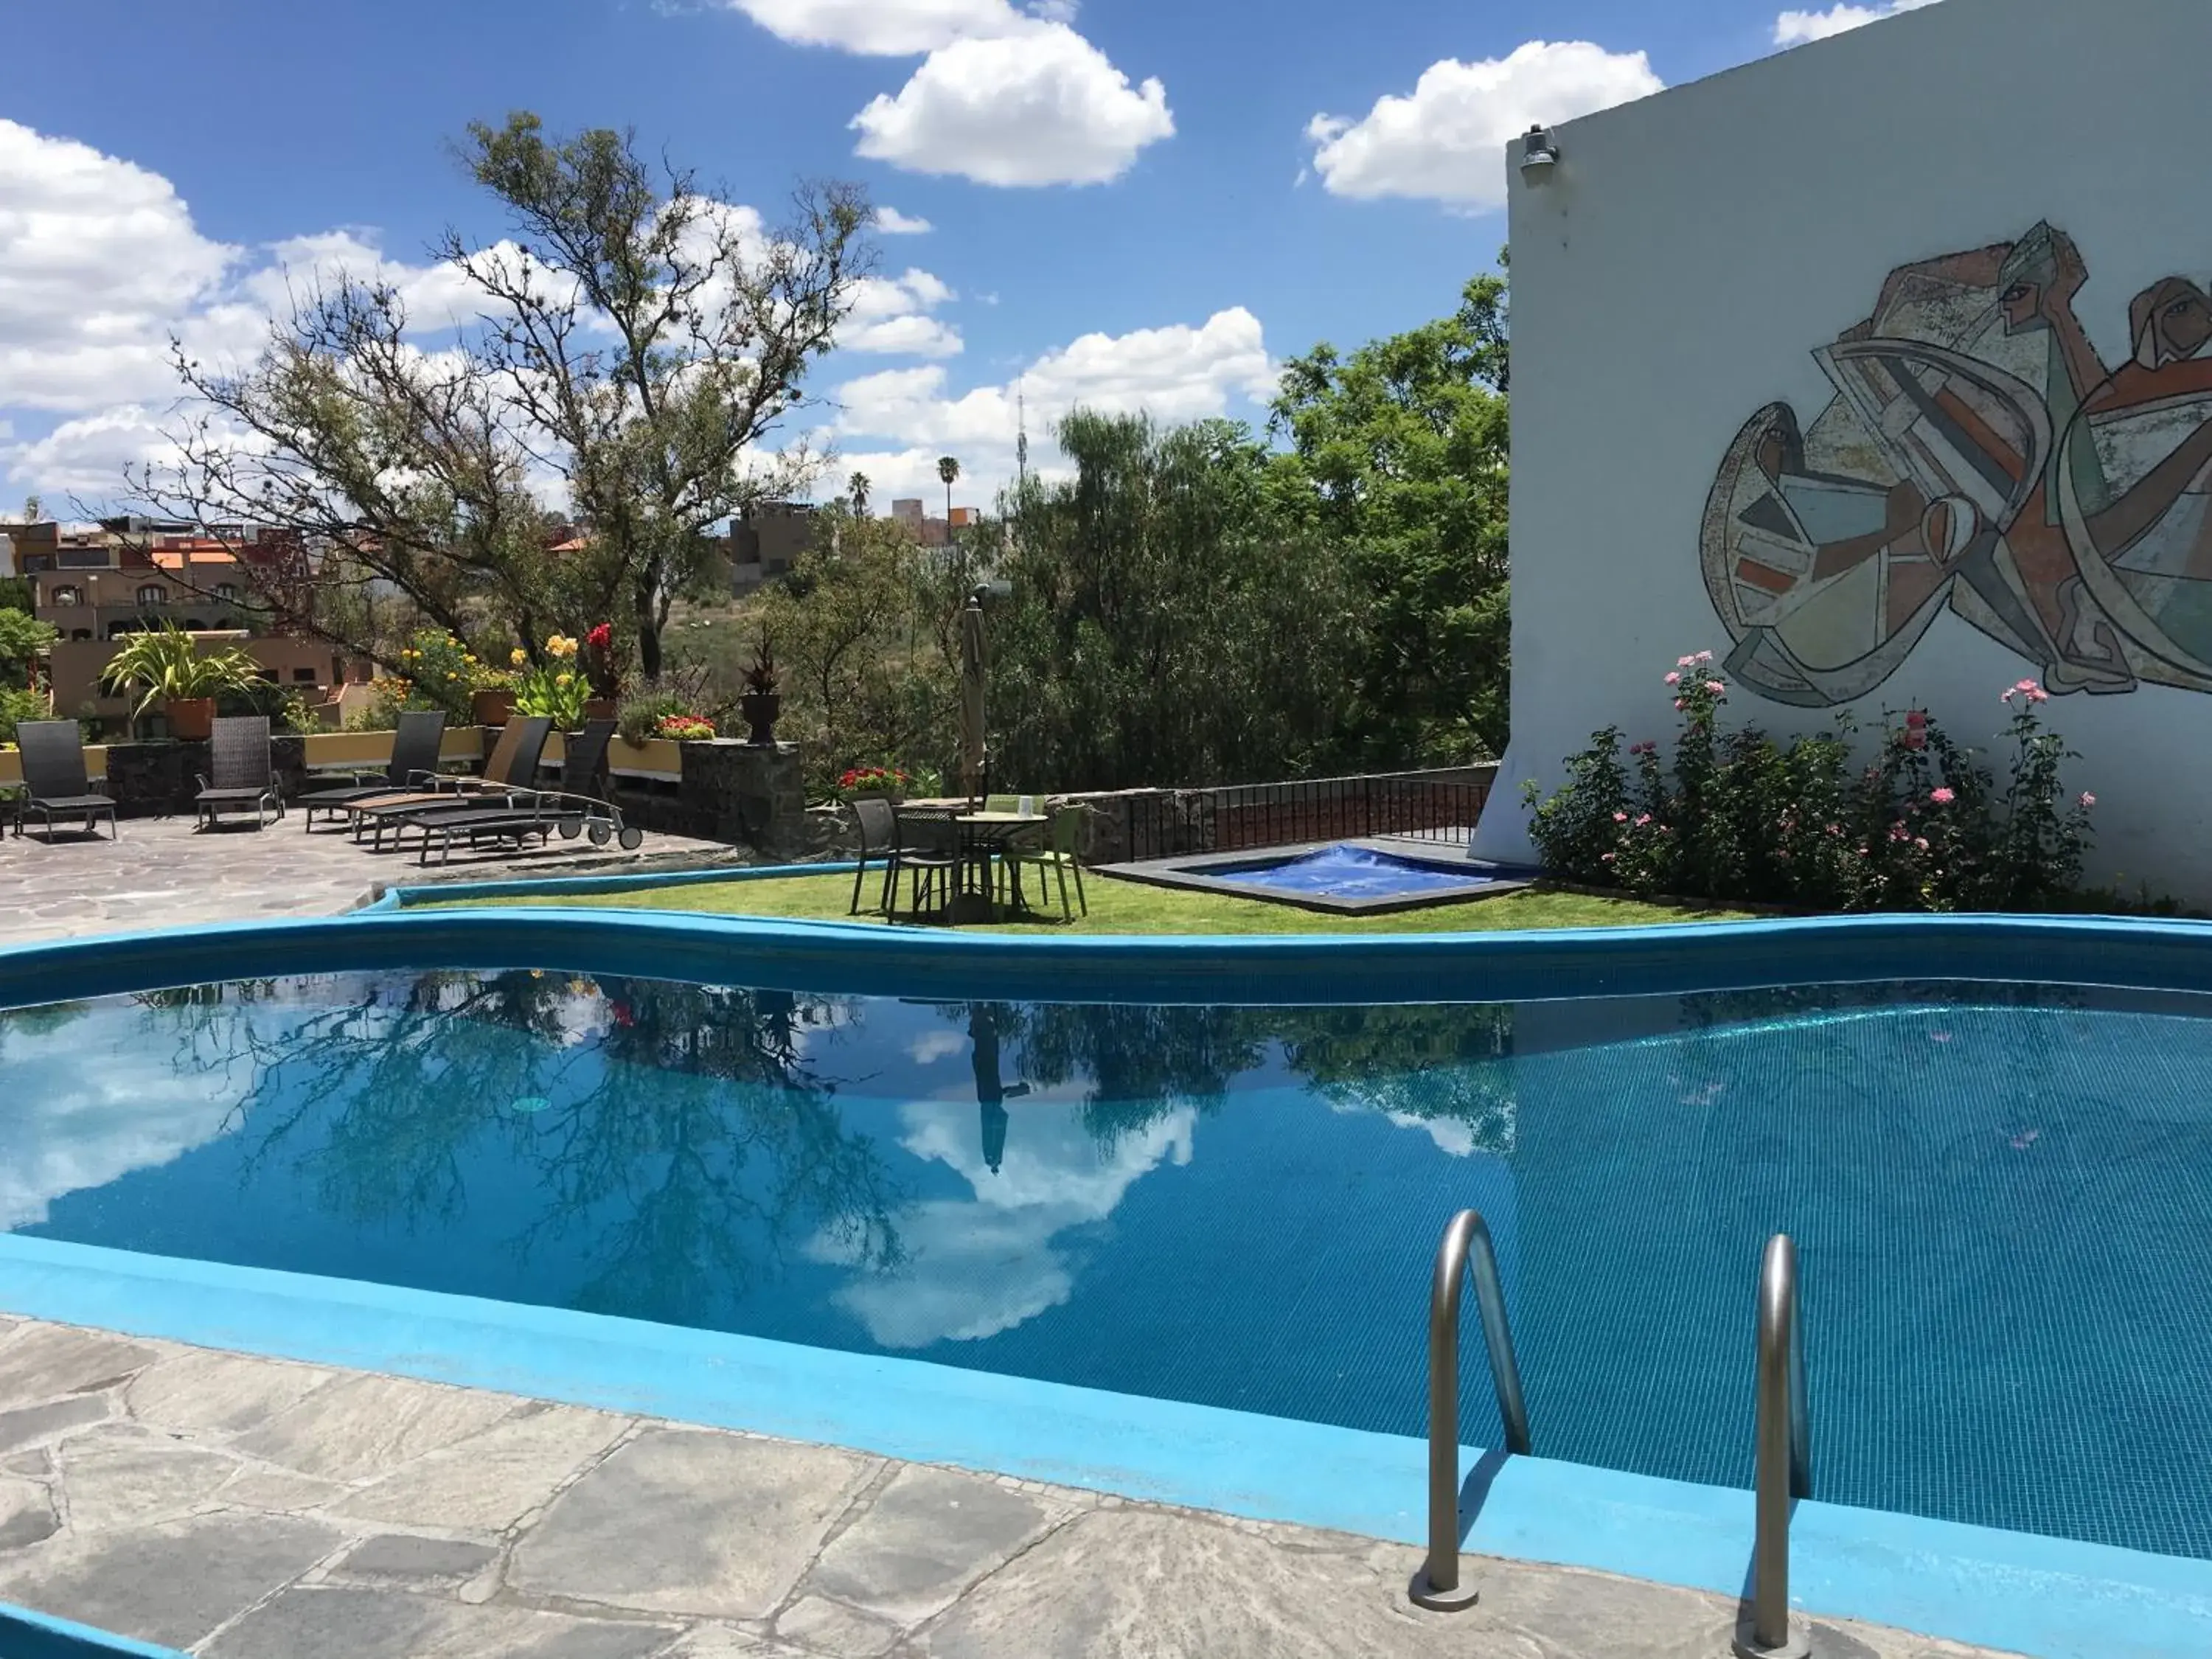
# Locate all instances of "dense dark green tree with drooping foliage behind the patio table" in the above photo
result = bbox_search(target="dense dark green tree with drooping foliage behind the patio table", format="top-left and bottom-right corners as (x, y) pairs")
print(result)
(991, 411), (1365, 790)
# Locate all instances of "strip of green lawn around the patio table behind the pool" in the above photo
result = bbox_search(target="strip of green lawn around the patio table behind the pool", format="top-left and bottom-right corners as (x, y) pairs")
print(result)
(465, 876), (1745, 933)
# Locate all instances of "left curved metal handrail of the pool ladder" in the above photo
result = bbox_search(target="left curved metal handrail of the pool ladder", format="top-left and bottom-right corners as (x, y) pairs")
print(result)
(1407, 1210), (1528, 1613)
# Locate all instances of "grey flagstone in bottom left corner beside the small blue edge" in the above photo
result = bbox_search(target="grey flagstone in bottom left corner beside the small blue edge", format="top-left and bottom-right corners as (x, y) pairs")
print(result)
(0, 1515), (338, 1655)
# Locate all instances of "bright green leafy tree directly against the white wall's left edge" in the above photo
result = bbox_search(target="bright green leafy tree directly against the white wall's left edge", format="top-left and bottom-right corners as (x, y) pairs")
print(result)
(1270, 276), (1511, 765)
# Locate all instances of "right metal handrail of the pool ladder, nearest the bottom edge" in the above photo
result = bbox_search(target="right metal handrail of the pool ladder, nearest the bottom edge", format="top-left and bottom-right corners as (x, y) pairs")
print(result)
(1734, 1232), (1812, 1659)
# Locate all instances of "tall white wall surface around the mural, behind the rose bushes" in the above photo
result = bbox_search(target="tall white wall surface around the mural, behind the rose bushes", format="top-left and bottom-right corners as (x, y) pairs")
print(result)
(1475, 0), (2212, 900)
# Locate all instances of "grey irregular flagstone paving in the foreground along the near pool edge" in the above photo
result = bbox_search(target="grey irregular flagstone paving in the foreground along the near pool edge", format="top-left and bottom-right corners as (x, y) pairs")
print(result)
(0, 1316), (2017, 1659)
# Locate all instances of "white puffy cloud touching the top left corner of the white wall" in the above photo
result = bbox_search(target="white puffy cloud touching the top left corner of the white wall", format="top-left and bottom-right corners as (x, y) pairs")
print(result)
(1305, 40), (1666, 210)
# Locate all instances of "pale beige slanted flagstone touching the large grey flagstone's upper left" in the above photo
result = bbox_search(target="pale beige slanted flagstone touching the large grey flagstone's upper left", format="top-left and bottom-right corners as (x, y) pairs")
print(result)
(338, 1405), (628, 1533)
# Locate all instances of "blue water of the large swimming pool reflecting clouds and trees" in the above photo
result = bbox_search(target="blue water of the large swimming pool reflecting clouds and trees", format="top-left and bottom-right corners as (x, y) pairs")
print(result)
(0, 971), (2212, 1555)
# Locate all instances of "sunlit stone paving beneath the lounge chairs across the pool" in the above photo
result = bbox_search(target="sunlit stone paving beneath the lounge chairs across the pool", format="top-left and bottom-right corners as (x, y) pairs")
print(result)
(0, 805), (752, 945)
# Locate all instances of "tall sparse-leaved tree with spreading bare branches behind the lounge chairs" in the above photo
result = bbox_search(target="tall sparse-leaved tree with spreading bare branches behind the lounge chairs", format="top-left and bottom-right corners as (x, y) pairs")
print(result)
(135, 113), (869, 679)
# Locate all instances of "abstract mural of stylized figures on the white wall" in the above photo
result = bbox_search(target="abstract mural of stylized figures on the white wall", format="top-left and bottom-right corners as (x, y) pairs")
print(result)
(1701, 226), (2212, 708)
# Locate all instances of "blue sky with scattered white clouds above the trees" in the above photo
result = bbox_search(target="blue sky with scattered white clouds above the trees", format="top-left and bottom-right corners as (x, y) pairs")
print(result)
(0, 0), (1927, 511)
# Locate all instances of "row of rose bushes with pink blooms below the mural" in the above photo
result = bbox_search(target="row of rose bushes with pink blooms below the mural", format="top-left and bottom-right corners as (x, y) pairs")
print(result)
(1526, 650), (2097, 909)
